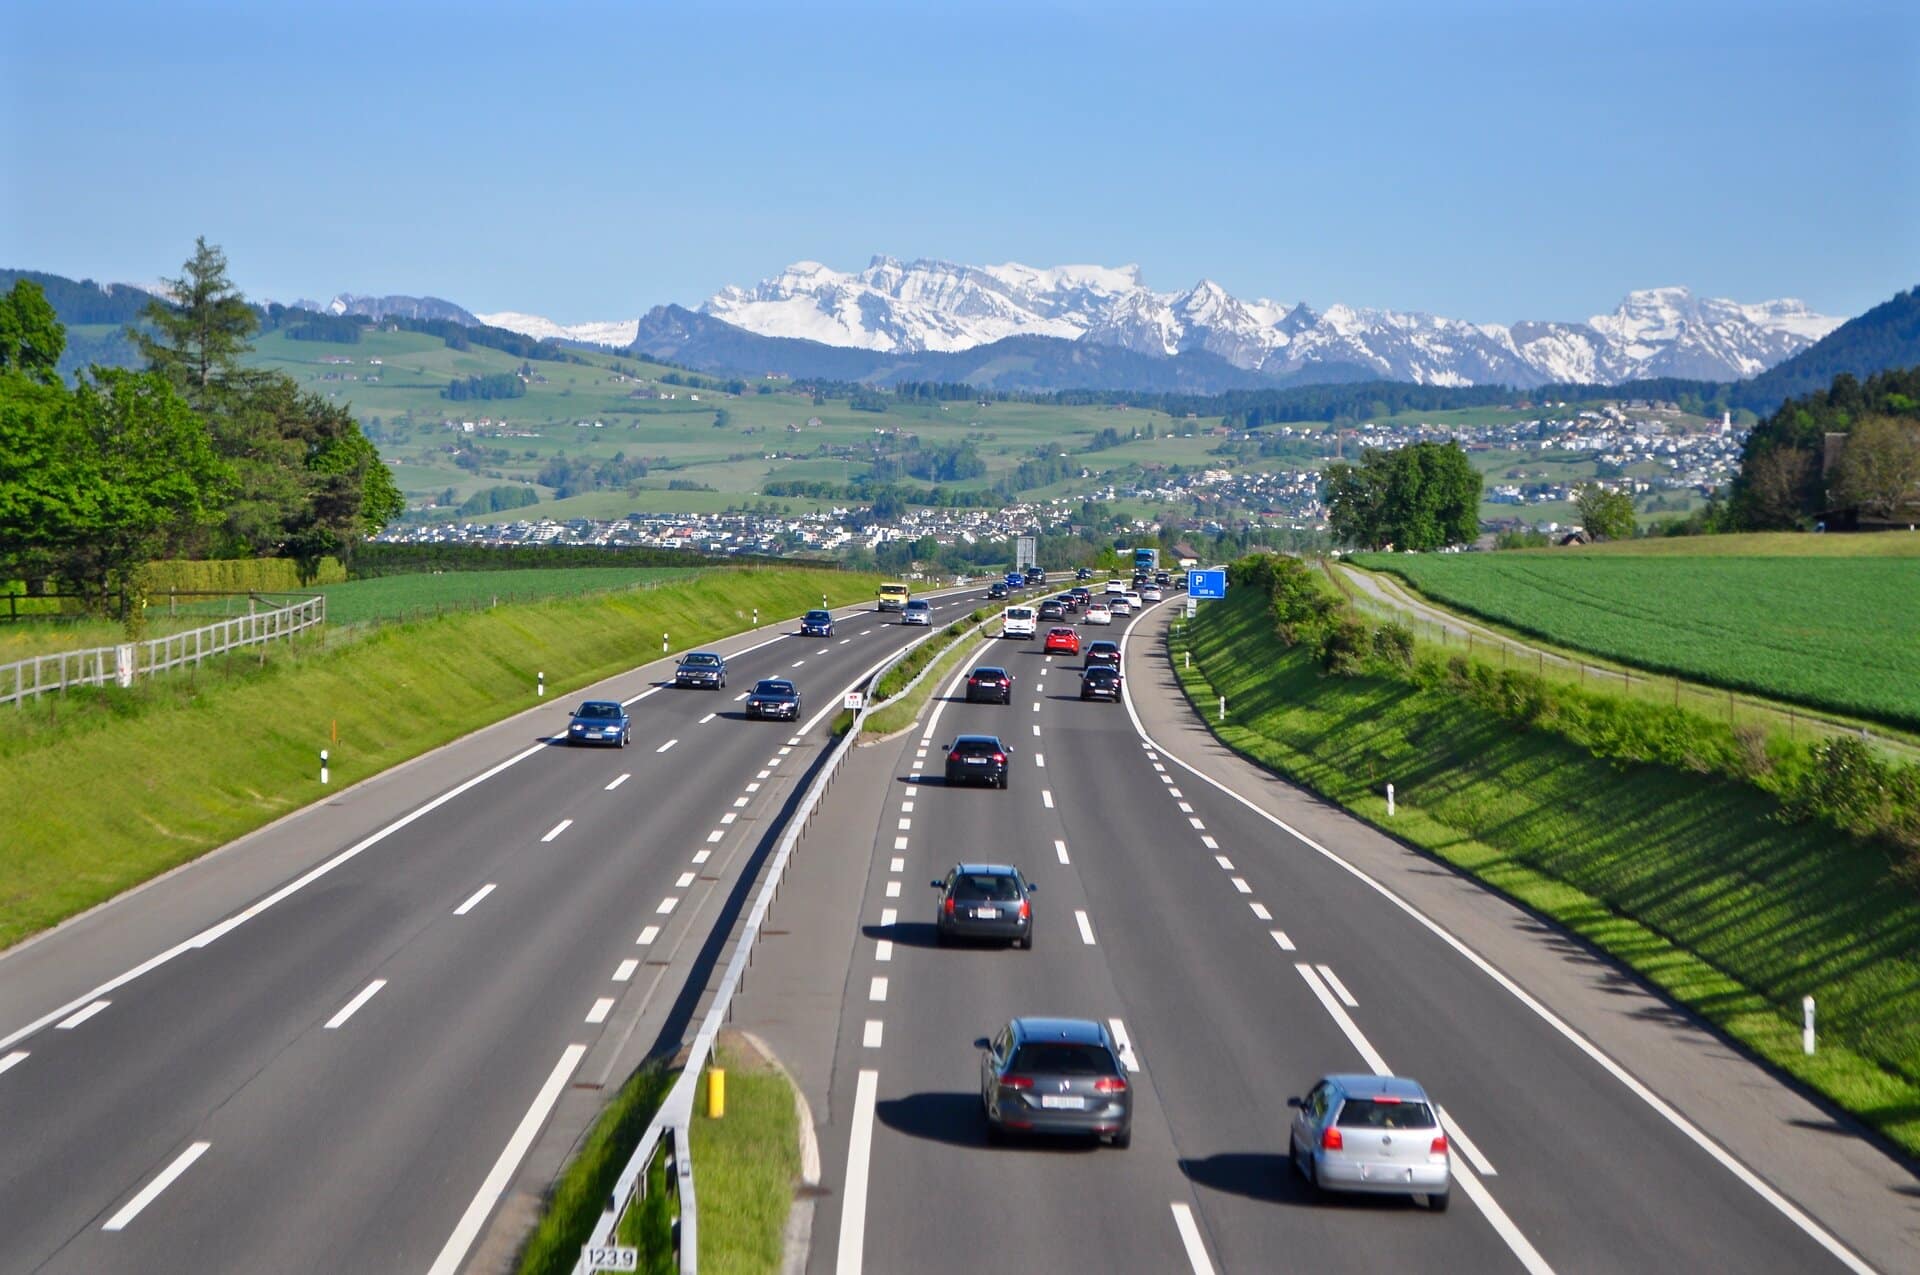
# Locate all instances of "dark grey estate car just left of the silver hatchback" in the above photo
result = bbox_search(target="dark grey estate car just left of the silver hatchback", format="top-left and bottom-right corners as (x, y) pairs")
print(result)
(979, 1018), (1133, 1146)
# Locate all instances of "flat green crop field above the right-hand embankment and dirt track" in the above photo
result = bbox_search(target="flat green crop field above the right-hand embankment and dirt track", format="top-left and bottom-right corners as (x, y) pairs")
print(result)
(1356, 536), (1920, 728)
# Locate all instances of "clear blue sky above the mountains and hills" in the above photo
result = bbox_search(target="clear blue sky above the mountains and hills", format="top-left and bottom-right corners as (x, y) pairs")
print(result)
(0, 0), (1920, 323)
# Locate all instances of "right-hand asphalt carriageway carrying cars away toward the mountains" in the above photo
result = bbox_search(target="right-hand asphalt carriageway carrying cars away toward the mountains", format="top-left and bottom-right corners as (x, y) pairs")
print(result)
(789, 599), (1920, 1275)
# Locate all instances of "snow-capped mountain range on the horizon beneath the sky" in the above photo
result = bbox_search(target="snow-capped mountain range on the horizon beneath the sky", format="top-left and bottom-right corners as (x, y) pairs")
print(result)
(695, 257), (1841, 386)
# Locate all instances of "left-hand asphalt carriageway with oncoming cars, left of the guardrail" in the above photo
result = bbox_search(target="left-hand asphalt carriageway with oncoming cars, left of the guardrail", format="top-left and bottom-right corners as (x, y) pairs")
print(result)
(0, 589), (981, 1273)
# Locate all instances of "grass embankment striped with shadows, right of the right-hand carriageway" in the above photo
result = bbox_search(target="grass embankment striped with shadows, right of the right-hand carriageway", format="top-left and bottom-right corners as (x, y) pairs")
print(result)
(1175, 588), (1920, 1154)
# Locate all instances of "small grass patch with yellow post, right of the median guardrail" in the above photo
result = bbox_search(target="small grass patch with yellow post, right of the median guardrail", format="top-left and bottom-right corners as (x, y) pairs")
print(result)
(689, 1045), (801, 1275)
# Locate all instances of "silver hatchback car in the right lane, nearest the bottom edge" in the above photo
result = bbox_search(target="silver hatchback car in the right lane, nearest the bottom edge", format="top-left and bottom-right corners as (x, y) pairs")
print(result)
(1286, 1073), (1453, 1214)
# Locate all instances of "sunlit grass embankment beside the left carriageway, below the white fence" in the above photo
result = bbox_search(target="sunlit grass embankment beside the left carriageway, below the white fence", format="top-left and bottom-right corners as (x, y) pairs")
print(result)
(0, 568), (876, 947)
